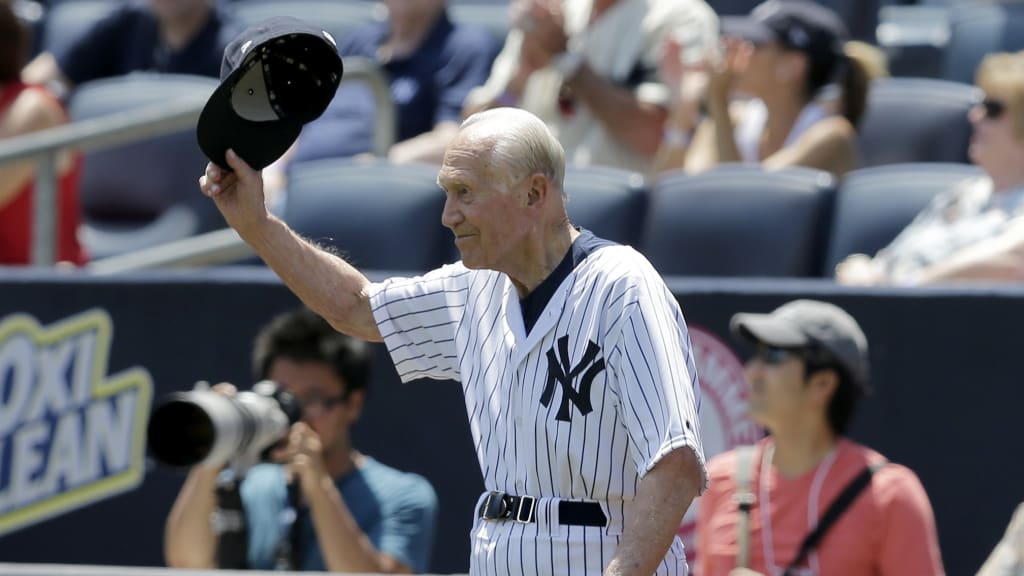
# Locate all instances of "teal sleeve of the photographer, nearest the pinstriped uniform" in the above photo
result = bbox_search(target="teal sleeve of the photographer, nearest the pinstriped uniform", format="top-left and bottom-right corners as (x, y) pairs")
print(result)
(380, 475), (437, 574)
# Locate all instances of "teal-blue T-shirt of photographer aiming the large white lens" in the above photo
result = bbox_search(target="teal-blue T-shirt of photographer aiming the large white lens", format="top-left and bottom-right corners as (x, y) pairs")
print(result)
(242, 457), (437, 572)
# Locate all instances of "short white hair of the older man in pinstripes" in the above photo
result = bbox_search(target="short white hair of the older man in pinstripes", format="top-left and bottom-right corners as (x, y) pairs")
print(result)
(460, 108), (565, 196)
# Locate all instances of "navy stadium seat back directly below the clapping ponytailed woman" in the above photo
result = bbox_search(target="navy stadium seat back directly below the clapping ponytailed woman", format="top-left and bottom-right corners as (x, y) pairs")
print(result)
(641, 165), (835, 277)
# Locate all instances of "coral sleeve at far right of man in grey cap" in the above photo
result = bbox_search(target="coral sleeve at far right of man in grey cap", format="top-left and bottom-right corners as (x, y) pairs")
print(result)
(878, 464), (944, 576)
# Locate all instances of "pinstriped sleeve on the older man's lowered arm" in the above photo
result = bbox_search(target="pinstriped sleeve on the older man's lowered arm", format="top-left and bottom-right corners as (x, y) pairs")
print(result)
(610, 260), (708, 492)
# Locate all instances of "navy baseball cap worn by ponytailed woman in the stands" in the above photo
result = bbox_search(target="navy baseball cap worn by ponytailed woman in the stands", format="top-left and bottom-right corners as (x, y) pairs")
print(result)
(721, 0), (850, 66)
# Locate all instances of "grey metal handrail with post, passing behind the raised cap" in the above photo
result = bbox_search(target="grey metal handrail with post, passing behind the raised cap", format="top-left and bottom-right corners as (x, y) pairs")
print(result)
(0, 57), (395, 265)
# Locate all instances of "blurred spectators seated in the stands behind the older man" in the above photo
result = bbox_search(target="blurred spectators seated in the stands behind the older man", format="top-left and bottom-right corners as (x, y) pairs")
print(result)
(0, 0), (1024, 285)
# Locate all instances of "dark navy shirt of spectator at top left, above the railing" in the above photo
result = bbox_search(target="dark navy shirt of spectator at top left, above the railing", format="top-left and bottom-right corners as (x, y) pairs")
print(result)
(54, 2), (242, 84)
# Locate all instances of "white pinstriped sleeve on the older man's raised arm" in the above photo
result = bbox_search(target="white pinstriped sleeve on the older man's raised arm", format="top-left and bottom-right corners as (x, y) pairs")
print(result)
(370, 264), (471, 382)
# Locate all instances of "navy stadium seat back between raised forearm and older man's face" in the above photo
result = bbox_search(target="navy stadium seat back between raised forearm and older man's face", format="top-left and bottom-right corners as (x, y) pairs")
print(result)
(283, 159), (454, 272)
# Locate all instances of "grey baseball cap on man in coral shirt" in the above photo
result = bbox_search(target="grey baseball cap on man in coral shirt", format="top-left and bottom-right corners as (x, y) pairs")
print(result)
(729, 300), (869, 389)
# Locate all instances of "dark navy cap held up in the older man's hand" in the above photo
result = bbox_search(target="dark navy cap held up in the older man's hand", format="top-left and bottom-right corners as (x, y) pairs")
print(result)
(196, 16), (343, 170)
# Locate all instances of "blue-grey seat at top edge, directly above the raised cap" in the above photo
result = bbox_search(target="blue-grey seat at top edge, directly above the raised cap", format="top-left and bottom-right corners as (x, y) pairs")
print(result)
(231, 0), (385, 40)
